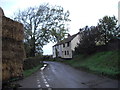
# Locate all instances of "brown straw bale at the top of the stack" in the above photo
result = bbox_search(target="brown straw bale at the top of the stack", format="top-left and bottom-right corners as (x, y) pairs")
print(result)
(2, 17), (24, 41)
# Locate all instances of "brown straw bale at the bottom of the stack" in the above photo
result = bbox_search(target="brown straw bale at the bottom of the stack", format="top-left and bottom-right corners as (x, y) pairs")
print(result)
(2, 60), (23, 80)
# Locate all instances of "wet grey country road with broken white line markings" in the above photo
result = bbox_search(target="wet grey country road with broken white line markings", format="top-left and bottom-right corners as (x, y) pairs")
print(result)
(14, 61), (118, 88)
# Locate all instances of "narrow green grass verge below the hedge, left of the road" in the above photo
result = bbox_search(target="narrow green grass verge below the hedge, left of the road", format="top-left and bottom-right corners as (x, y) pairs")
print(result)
(23, 64), (43, 77)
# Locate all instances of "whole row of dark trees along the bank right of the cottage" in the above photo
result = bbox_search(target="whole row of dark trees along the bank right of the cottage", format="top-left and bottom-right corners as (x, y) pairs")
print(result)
(74, 16), (120, 54)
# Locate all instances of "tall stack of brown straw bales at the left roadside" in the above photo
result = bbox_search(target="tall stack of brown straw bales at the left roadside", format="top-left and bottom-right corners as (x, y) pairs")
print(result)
(2, 7), (25, 81)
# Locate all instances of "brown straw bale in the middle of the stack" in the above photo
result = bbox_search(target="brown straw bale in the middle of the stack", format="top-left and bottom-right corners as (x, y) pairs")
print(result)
(2, 38), (25, 60)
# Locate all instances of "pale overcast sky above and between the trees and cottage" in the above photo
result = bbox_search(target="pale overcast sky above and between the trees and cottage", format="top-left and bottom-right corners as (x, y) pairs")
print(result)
(0, 0), (120, 54)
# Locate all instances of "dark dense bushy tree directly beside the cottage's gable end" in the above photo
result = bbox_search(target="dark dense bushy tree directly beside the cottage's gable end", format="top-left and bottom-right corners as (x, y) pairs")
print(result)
(74, 26), (99, 54)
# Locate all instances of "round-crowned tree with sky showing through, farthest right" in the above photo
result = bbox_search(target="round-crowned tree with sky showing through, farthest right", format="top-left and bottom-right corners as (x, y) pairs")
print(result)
(97, 16), (120, 45)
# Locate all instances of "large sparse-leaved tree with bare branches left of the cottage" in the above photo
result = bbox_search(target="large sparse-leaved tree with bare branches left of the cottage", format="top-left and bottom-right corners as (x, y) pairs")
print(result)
(14, 4), (70, 56)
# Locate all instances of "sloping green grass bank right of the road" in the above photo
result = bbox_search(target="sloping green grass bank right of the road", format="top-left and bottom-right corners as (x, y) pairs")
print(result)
(62, 51), (120, 78)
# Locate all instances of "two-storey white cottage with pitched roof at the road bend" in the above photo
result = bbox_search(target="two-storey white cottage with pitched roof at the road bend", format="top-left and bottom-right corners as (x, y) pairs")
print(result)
(53, 33), (80, 59)
